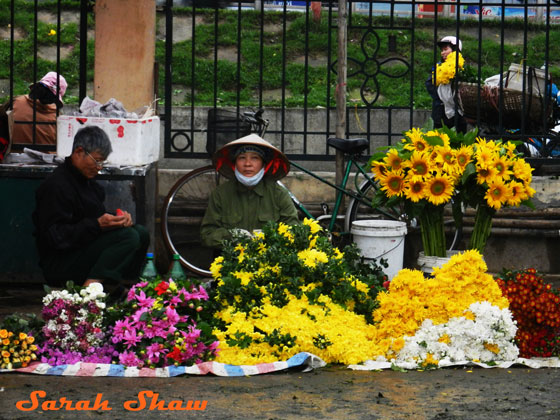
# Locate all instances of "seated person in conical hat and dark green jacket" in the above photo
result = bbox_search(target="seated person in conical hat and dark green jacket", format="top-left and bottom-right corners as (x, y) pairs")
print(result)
(200, 134), (299, 248)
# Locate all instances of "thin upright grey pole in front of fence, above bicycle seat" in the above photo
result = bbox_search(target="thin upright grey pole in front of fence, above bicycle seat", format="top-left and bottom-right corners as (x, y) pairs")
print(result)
(336, 0), (348, 190)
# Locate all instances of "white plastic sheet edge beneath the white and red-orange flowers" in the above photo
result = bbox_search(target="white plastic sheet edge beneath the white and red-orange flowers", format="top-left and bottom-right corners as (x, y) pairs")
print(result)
(348, 357), (560, 370)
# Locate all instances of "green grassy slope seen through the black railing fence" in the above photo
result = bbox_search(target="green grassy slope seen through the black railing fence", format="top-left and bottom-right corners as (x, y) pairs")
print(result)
(0, 0), (560, 109)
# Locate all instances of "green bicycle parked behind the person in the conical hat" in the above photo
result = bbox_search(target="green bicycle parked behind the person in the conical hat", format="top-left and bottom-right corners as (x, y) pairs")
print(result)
(161, 110), (402, 277)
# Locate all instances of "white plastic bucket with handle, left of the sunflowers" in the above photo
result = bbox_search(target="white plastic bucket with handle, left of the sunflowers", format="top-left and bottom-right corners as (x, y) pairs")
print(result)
(351, 220), (406, 280)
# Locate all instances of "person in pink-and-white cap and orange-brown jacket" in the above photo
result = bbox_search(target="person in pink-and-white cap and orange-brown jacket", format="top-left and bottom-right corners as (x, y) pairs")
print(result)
(0, 71), (68, 144)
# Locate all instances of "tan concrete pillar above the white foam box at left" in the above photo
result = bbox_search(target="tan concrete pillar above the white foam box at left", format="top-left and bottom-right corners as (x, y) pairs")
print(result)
(94, 0), (156, 111)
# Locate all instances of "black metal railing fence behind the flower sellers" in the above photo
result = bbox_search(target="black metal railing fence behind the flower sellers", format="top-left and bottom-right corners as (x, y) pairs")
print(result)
(0, 0), (560, 160)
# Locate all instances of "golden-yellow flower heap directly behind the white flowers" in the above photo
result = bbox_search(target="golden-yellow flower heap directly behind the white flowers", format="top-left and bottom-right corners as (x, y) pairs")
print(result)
(373, 250), (508, 359)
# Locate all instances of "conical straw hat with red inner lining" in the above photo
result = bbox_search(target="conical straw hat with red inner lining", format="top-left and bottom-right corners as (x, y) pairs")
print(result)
(212, 134), (290, 180)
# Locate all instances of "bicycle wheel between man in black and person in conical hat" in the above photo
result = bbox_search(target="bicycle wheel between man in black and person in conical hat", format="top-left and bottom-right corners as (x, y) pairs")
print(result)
(161, 166), (226, 277)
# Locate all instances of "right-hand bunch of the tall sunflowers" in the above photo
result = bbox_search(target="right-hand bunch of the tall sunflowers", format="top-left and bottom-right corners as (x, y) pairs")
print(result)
(473, 138), (535, 210)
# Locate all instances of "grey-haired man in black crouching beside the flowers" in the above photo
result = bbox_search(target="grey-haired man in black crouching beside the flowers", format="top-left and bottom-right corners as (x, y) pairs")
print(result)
(33, 126), (150, 287)
